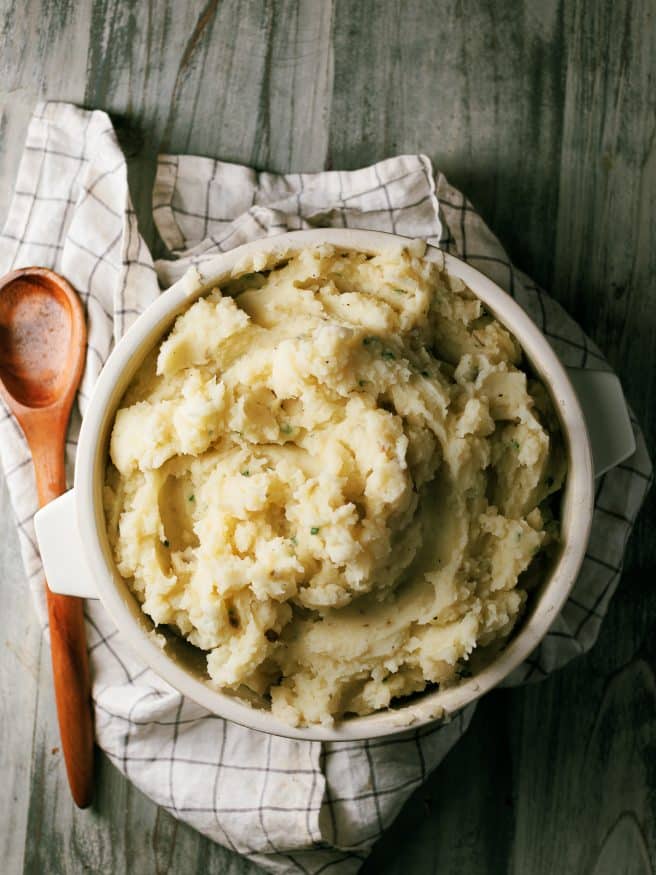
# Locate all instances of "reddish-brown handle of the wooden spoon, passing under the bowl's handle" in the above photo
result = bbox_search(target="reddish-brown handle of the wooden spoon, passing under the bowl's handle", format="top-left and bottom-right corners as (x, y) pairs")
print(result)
(32, 441), (94, 808)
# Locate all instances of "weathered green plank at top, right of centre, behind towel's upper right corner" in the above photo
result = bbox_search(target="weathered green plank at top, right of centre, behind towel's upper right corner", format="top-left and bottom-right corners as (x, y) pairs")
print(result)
(330, 0), (571, 294)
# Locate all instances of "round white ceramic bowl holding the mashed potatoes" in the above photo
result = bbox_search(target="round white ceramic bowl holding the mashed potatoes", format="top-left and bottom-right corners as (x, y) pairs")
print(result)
(36, 229), (630, 741)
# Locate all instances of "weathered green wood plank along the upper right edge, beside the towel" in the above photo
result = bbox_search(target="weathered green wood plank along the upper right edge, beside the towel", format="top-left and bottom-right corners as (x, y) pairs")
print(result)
(553, 0), (656, 569)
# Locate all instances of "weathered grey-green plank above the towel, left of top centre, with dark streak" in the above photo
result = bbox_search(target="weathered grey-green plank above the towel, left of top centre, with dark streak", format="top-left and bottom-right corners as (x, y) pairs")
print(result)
(84, 0), (332, 253)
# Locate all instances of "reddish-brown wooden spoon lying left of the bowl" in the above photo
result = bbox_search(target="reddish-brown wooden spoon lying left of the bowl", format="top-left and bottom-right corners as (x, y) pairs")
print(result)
(0, 267), (93, 808)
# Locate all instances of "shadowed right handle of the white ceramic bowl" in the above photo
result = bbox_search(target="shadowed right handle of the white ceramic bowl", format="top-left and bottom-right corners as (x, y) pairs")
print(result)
(567, 368), (636, 477)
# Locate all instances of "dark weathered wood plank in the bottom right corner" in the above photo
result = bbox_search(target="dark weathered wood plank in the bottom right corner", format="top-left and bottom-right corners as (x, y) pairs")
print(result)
(511, 574), (656, 875)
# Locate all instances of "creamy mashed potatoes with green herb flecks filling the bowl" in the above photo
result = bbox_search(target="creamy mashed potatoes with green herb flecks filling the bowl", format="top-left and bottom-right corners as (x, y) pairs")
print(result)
(105, 244), (564, 724)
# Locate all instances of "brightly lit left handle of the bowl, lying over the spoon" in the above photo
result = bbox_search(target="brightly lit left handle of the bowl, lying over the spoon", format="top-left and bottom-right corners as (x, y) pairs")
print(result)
(34, 489), (98, 599)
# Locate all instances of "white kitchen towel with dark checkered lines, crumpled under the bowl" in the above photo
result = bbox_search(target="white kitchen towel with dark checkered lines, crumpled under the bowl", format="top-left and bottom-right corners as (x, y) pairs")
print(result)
(0, 103), (651, 875)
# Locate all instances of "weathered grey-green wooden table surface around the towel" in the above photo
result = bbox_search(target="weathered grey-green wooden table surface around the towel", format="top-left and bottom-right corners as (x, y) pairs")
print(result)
(0, 0), (656, 875)
